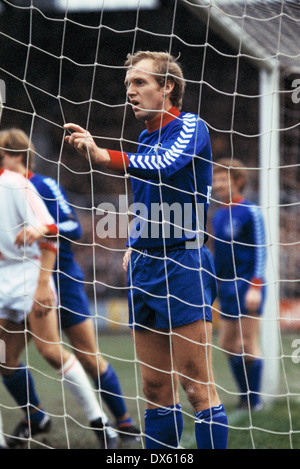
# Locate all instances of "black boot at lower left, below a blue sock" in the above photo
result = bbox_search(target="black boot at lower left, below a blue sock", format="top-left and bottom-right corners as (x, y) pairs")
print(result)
(6, 415), (51, 448)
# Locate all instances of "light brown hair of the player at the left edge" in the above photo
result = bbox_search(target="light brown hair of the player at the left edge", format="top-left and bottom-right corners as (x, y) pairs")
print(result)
(0, 128), (35, 169)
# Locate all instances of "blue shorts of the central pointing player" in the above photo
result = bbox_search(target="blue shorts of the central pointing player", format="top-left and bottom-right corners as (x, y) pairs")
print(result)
(127, 246), (217, 330)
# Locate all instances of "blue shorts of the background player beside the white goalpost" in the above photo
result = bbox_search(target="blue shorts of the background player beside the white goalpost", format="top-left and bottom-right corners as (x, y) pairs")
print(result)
(218, 279), (266, 320)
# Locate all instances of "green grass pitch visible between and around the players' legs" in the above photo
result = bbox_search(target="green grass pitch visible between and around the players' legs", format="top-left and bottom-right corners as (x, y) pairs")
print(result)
(0, 333), (300, 449)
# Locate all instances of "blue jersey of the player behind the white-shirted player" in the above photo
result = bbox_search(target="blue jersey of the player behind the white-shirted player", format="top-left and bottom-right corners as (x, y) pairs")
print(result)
(30, 173), (82, 277)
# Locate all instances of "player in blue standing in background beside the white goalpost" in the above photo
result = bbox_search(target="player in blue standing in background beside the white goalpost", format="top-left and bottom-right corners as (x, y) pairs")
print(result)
(213, 158), (266, 410)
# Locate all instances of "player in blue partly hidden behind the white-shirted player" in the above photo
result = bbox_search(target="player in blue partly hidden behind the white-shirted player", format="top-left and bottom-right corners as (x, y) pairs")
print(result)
(1, 128), (140, 448)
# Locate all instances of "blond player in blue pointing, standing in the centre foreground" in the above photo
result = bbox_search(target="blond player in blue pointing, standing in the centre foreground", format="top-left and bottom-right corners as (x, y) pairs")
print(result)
(65, 51), (228, 449)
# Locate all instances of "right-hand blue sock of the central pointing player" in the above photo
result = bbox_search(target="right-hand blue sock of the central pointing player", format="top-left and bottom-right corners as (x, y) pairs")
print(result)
(195, 404), (228, 449)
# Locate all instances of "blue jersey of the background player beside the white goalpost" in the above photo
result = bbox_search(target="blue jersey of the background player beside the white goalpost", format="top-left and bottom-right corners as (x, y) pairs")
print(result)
(213, 200), (266, 283)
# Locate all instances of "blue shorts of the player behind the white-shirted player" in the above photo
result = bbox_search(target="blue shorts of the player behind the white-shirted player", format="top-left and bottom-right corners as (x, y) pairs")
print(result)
(54, 266), (90, 329)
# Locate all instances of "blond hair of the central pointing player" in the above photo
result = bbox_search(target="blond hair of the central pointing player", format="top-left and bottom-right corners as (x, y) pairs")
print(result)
(125, 51), (185, 110)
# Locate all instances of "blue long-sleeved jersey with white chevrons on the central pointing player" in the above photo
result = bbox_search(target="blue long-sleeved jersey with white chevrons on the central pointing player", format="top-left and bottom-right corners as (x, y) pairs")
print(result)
(127, 112), (212, 249)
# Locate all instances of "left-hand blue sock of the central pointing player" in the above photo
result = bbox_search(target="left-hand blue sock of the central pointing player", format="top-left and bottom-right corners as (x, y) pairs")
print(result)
(145, 404), (183, 449)
